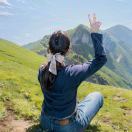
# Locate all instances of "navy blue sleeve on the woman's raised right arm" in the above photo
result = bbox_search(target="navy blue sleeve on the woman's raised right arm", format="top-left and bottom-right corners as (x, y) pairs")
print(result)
(69, 33), (107, 84)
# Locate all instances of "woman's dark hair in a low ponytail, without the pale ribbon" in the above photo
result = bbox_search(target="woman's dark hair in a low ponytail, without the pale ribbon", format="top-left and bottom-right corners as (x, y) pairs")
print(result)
(42, 31), (70, 90)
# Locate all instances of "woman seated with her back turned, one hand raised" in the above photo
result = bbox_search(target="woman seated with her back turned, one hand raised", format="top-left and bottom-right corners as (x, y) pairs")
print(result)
(38, 15), (107, 132)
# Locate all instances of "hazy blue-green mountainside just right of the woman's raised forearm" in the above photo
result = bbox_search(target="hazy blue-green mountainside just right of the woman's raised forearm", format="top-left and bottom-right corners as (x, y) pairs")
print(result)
(104, 33), (132, 82)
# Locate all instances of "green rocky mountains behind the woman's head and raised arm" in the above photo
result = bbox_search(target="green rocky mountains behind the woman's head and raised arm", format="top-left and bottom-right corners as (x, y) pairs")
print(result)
(24, 24), (132, 88)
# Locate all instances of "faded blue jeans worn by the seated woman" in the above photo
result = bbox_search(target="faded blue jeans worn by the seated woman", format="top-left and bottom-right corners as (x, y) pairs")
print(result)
(40, 92), (103, 132)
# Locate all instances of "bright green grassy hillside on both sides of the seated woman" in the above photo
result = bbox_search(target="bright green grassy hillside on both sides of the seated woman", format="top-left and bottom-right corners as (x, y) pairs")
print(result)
(0, 40), (132, 132)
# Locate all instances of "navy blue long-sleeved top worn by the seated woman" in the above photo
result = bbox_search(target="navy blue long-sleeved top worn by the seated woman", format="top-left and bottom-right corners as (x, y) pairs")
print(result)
(38, 33), (107, 119)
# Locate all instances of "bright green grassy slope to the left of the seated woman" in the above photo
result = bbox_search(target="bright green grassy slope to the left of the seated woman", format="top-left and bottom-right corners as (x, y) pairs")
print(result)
(0, 40), (46, 118)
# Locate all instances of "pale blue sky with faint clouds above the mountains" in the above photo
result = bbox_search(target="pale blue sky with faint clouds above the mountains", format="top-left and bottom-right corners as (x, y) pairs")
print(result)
(0, 0), (132, 45)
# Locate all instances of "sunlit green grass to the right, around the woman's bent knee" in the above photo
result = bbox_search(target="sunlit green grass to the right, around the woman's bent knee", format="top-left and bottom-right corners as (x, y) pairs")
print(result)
(78, 82), (132, 131)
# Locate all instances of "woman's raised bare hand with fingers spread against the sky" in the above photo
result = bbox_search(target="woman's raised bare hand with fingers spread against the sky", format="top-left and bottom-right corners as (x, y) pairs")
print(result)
(88, 13), (102, 32)
